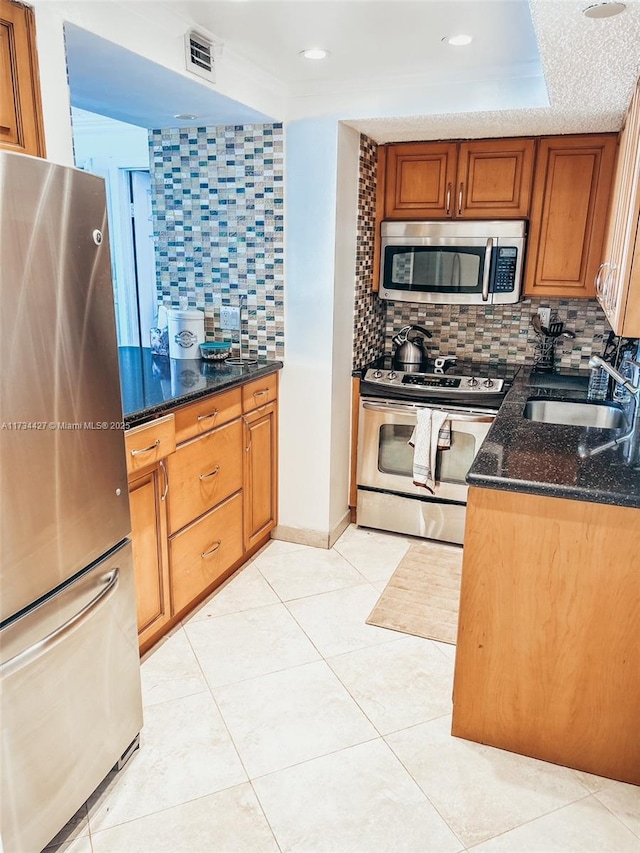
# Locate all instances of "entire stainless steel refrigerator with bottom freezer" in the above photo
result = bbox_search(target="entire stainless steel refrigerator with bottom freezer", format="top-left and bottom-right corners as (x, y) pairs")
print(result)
(0, 151), (142, 853)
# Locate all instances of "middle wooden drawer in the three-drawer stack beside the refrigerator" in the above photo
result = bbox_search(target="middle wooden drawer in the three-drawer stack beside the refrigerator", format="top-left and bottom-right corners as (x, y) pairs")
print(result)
(168, 420), (242, 533)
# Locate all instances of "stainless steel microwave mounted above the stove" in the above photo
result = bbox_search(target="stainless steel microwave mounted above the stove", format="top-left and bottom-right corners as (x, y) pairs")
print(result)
(379, 220), (527, 305)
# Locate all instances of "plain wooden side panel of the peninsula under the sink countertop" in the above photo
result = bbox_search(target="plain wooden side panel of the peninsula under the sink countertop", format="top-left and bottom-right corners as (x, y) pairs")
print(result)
(452, 487), (640, 785)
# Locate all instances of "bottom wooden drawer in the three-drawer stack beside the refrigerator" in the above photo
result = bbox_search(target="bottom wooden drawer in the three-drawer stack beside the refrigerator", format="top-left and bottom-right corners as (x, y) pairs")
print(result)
(169, 494), (242, 614)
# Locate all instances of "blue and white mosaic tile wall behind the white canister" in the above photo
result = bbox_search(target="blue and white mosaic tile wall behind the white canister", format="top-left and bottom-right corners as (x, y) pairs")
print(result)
(149, 124), (284, 358)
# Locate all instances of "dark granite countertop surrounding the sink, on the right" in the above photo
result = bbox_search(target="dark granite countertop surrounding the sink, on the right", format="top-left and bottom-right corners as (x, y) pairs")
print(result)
(467, 368), (640, 507)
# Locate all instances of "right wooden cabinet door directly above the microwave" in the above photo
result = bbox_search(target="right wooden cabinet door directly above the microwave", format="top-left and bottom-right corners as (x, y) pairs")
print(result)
(455, 139), (535, 219)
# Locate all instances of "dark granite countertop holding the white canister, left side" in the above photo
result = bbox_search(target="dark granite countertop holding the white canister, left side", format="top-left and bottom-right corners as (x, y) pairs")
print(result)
(118, 347), (283, 427)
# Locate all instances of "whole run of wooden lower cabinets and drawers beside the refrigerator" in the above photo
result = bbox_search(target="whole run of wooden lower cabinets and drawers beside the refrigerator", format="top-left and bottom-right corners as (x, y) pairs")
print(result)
(125, 373), (278, 652)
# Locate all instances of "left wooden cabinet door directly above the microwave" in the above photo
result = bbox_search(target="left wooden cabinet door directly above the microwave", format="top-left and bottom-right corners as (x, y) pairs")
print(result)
(385, 142), (457, 219)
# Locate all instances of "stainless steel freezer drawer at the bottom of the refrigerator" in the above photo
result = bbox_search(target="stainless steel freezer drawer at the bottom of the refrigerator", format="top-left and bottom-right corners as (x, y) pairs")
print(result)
(0, 540), (142, 853)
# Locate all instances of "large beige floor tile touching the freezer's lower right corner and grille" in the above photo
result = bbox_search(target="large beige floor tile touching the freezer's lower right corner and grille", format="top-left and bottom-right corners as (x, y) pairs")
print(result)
(89, 692), (247, 832)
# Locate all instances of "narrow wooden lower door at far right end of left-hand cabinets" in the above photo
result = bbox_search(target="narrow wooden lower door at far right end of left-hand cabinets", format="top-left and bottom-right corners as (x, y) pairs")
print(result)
(244, 403), (278, 550)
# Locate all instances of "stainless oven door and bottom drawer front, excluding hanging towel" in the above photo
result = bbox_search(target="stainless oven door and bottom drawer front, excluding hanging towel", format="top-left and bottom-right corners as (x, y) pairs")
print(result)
(357, 397), (496, 543)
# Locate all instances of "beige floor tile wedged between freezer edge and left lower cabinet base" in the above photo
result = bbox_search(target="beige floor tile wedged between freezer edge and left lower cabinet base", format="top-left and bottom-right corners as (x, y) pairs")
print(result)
(140, 628), (209, 706)
